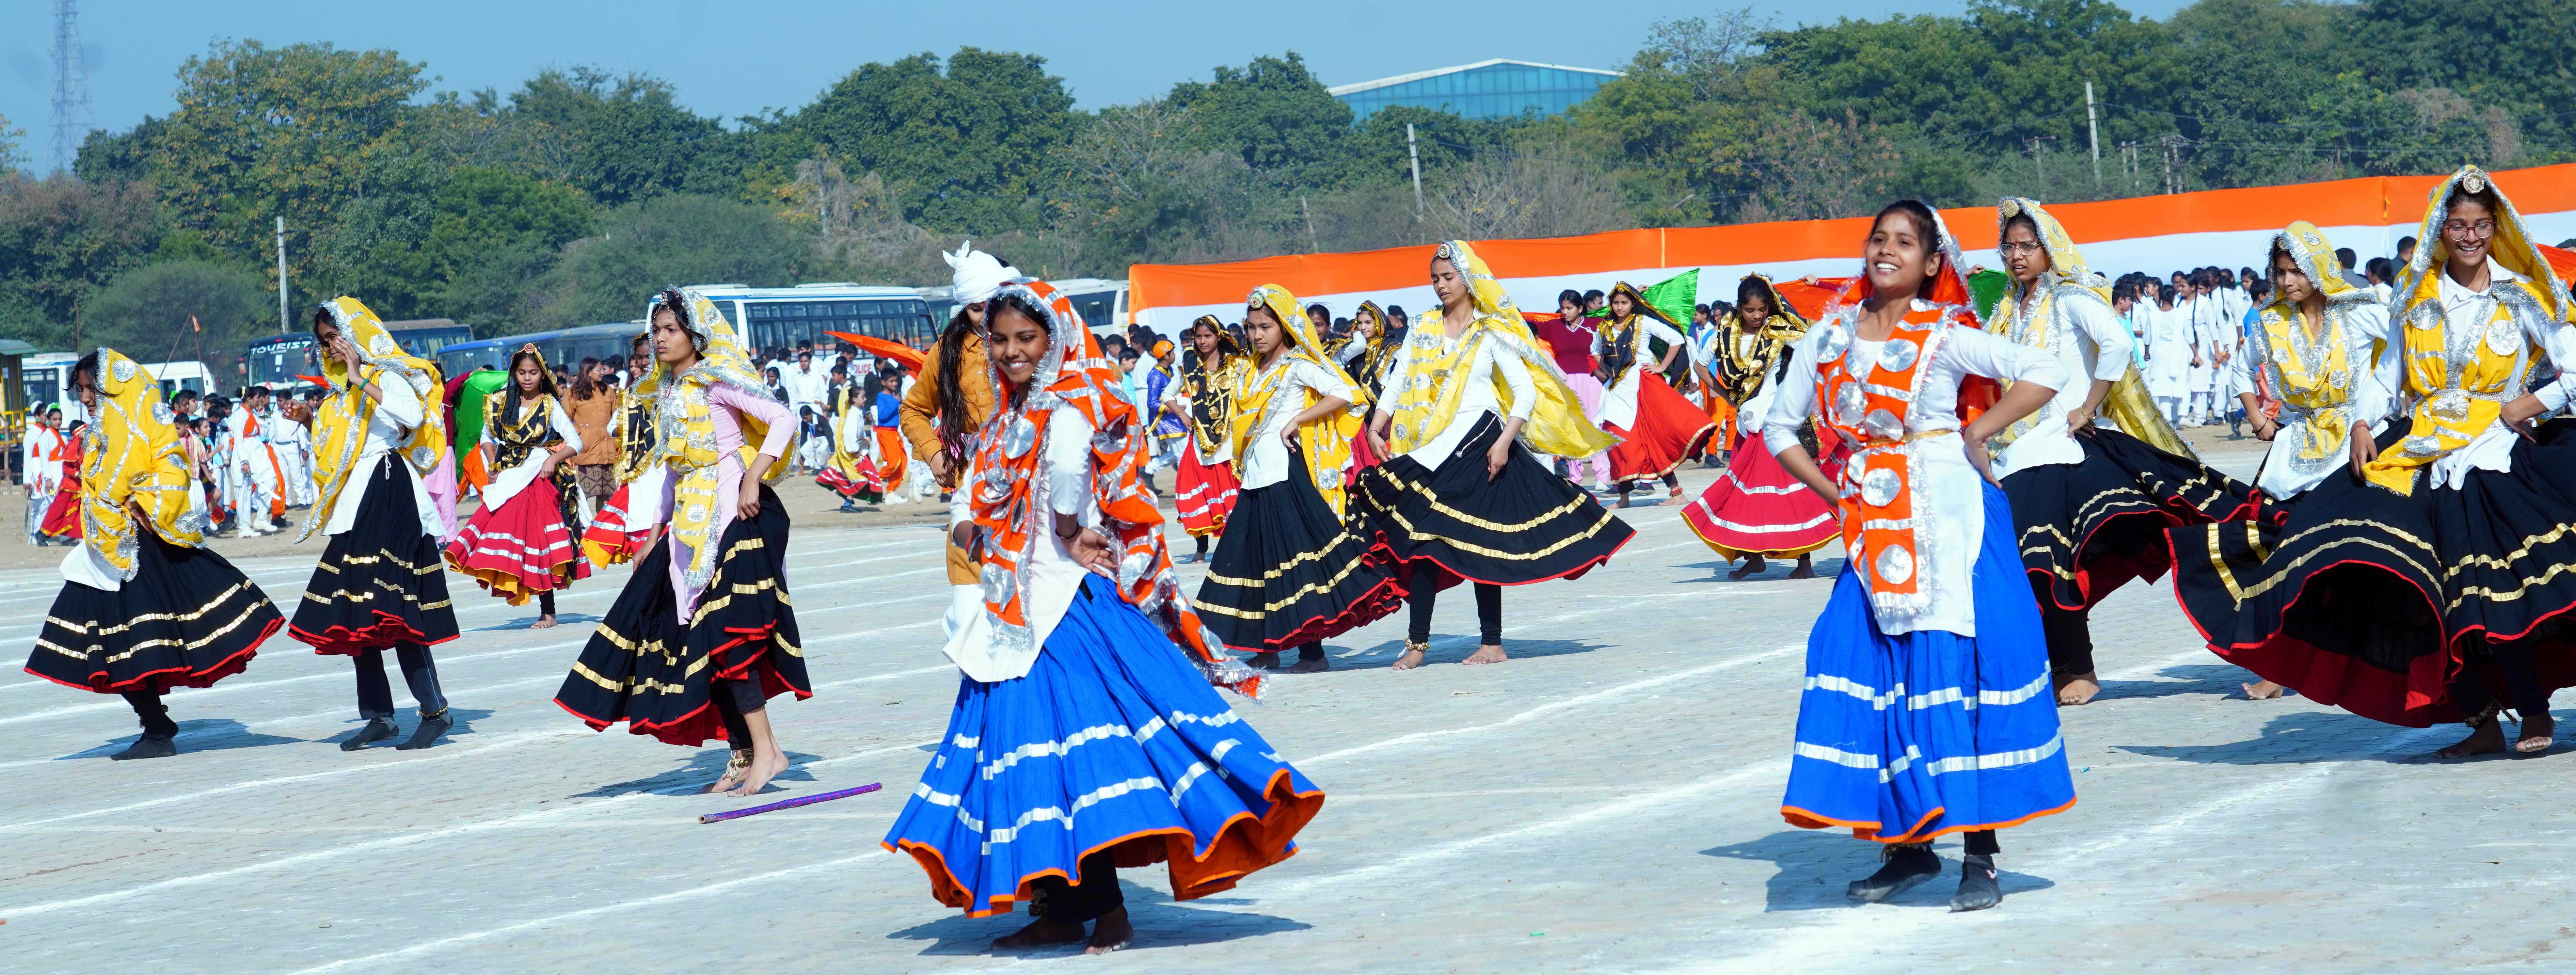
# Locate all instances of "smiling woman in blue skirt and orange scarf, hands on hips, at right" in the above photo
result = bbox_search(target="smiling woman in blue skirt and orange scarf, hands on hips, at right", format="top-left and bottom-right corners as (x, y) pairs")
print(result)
(1762, 201), (2076, 911)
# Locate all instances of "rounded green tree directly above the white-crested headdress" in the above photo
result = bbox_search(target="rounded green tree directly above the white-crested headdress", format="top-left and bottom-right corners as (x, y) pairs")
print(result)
(765, 46), (1074, 234)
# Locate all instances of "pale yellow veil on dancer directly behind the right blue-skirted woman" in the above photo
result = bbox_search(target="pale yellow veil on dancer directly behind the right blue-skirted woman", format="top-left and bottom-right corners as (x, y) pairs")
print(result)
(1986, 195), (2197, 458)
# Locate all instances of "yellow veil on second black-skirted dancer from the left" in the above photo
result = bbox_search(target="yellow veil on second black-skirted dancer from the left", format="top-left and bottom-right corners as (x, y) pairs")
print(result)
(296, 296), (448, 543)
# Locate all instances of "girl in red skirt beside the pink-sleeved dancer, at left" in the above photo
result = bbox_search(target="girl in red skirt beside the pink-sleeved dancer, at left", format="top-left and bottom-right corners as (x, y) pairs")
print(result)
(446, 345), (590, 628)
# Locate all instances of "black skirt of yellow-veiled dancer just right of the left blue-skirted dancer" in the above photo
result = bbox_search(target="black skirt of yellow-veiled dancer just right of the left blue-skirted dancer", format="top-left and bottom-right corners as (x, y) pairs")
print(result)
(1190, 450), (1404, 653)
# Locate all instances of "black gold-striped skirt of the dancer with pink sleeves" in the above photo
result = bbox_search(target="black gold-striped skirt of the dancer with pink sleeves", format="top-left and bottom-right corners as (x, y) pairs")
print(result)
(554, 486), (814, 749)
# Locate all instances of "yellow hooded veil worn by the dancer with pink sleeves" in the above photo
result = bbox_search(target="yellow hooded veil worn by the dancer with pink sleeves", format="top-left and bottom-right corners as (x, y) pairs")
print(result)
(634, 288), (788, 587)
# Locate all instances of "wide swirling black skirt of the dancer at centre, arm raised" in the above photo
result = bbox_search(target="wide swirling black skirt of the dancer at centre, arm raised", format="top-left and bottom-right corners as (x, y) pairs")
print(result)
(1352, 414), (1636, 589)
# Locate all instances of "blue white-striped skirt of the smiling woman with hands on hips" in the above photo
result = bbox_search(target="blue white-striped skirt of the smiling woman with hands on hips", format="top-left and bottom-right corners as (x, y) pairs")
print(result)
(1780, 484), (2076, 844)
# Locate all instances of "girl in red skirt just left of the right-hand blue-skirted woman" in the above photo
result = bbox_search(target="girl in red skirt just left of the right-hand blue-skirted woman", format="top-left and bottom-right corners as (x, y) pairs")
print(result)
(1682, 275), (1842, 579)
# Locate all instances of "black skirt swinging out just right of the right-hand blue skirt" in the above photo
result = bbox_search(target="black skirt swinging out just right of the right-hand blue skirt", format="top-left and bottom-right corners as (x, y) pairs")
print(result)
(2004, 427), (2254, 610)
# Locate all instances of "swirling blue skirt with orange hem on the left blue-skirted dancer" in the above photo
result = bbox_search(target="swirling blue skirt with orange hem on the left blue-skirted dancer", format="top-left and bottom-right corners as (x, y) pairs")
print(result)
(884, 579), (1324, 916)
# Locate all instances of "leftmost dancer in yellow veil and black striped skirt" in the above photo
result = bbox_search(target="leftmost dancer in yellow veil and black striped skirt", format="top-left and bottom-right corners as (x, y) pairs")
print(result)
(26, 347), (286, 759)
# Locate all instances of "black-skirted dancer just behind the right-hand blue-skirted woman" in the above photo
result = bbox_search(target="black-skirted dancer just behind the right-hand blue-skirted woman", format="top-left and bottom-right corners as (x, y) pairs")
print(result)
(1994, 198), (2252, 705)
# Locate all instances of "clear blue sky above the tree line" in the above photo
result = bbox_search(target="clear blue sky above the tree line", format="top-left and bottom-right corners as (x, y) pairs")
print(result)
(0, 0), (2179, 167)
